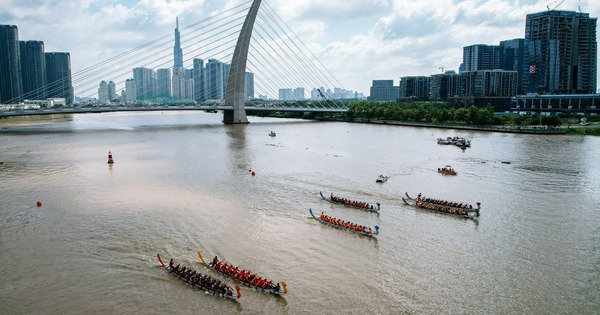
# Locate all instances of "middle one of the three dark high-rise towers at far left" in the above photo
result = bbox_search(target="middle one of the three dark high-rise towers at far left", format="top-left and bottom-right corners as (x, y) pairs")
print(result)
(19, 40), (46, 100)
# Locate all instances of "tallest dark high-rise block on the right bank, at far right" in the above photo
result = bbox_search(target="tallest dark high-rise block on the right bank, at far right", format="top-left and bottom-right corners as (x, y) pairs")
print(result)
(523, 10), (598, 94)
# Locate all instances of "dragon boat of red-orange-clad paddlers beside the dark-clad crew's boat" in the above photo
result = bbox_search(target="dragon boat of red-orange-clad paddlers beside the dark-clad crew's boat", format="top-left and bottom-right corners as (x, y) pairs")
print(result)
(198, 251), (287, 295)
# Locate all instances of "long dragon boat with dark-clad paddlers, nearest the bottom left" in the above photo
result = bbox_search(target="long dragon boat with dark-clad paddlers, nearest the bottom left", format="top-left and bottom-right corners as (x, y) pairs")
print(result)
(156, 254), (242, 300)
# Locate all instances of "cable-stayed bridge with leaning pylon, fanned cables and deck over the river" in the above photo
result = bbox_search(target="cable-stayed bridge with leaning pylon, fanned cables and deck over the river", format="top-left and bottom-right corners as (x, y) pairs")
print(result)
(0, 0), (352, 123)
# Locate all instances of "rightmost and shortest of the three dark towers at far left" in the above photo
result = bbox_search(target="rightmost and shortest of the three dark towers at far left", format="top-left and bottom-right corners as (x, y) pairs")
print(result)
(44, 52), (74, 105)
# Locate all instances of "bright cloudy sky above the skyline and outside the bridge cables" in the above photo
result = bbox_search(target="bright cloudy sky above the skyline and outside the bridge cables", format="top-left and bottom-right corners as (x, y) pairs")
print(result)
(0, 0), (600, 96)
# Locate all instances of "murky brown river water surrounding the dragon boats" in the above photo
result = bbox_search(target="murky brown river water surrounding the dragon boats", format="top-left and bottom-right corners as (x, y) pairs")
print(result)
(0, 112), (600, 314)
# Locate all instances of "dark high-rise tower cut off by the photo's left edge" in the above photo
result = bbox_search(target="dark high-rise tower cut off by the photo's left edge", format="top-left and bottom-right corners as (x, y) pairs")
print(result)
(0, 25), (23, 103)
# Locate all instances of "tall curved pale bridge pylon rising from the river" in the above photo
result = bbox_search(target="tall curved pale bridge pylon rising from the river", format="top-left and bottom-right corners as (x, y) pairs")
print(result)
(223, 0), (261, 124)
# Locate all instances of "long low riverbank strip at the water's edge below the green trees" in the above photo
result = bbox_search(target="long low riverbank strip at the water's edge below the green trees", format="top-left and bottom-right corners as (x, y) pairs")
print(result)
(318, 118), (600, 136)
